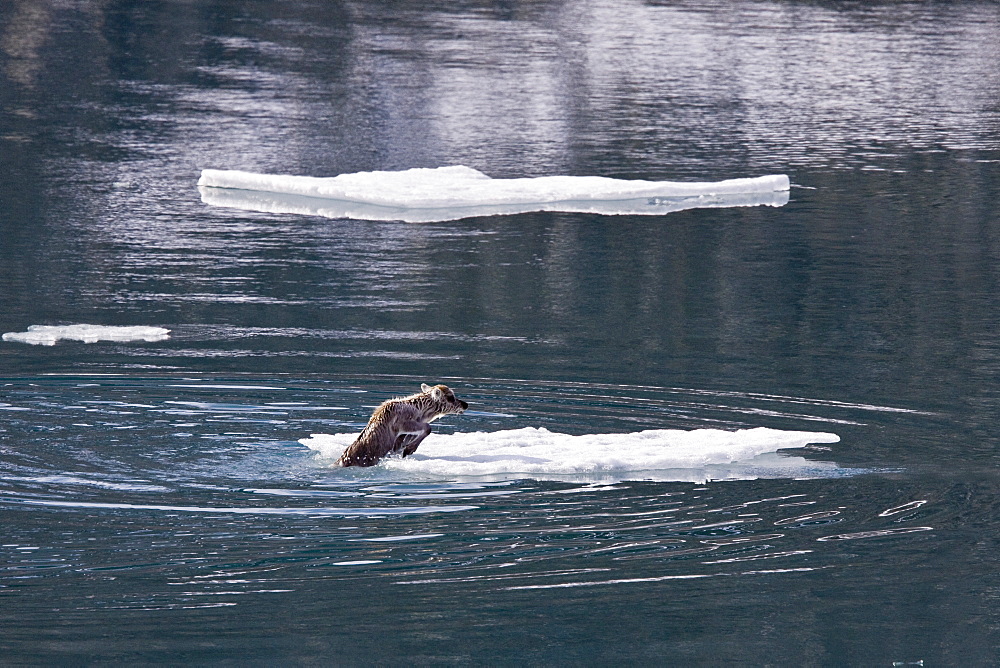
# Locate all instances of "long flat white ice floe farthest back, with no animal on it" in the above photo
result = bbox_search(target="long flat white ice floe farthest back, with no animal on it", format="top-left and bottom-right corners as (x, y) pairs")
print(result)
(198, 165), (789, 223)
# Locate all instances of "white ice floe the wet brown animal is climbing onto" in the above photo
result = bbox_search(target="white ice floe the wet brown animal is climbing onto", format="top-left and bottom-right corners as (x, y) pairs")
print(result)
(299, 427), (850, 482)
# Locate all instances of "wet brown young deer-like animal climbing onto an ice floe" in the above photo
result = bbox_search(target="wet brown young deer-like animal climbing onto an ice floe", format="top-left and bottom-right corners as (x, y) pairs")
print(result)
(337, 384), (469, 466)
